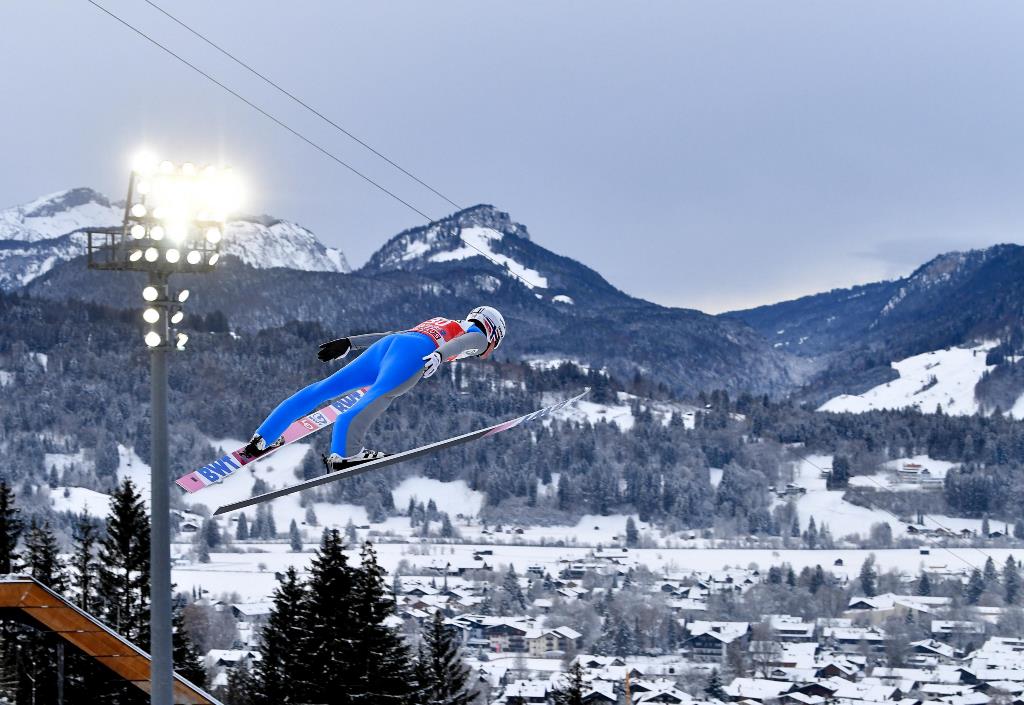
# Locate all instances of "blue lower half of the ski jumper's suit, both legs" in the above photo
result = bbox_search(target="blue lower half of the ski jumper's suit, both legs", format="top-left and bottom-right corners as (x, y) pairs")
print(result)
(256, 332), (437, 457)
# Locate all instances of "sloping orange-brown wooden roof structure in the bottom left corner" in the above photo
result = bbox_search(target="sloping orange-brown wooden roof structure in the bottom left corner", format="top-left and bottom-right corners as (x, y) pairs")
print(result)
(0, 574), (221, 705)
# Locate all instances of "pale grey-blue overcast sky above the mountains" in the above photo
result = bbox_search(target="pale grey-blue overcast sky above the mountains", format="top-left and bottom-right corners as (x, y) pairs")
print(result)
(0, 0), (1024, 312)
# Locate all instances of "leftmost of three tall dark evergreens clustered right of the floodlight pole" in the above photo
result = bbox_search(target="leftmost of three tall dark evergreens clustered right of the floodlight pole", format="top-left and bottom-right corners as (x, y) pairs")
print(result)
(253, 567), (309, 705)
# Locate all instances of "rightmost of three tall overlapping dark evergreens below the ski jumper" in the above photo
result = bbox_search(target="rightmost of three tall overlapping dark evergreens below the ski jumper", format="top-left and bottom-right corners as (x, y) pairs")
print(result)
(351, 541), (419, 705)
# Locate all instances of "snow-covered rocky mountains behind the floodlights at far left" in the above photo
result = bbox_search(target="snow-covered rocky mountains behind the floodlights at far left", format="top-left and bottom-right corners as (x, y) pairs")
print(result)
(0, 189), (350, 290)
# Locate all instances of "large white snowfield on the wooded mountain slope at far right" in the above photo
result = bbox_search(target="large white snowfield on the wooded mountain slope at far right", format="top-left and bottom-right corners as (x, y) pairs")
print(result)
(818, 342), (1003, 418)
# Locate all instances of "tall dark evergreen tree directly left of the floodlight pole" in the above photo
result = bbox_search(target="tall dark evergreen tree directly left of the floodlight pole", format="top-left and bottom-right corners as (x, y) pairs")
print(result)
(99, 479), (150, 649)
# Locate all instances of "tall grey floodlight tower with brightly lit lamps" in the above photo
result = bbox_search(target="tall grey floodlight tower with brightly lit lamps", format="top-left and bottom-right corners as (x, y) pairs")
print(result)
(88, 155), (240, 705)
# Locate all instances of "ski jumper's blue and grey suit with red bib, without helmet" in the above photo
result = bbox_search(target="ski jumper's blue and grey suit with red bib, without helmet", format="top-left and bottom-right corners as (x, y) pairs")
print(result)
(250, 318), (487, 457)
